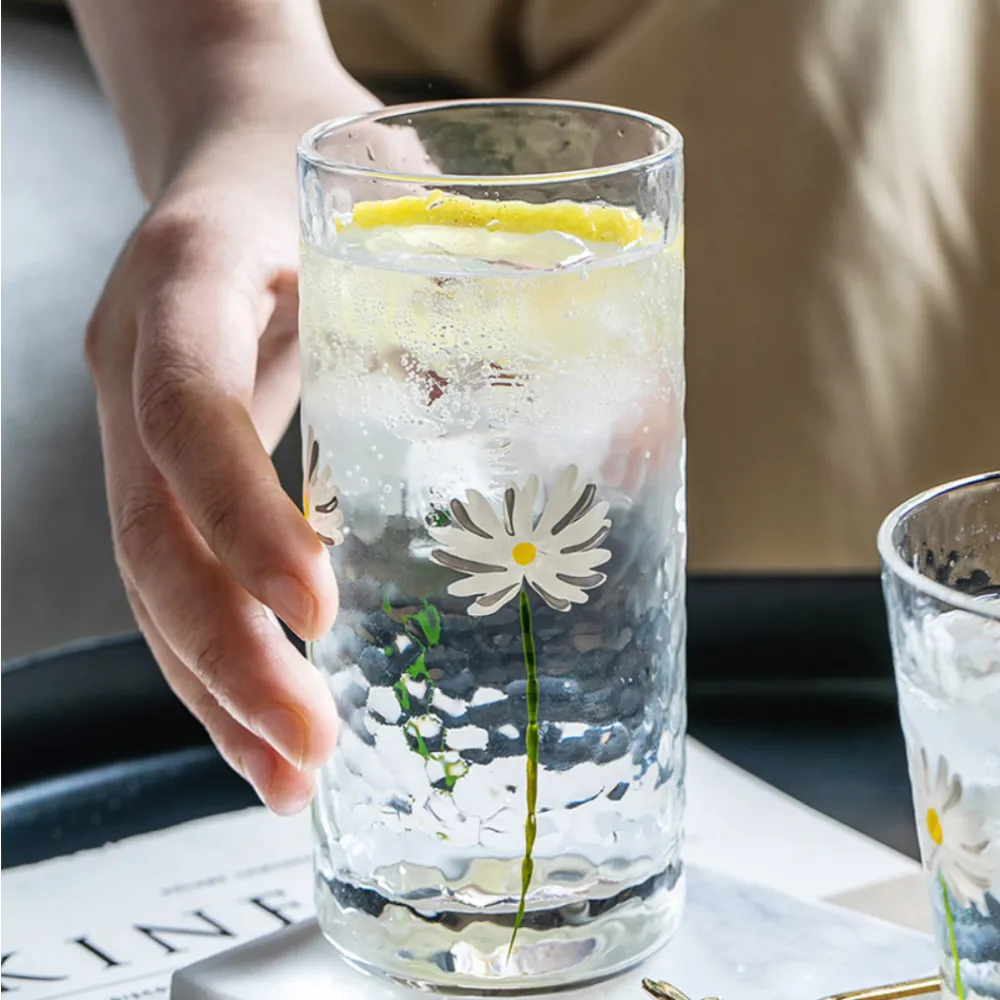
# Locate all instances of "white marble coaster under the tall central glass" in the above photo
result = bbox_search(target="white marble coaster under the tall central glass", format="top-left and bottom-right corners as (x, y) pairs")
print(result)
(171, 869), (934, 1000)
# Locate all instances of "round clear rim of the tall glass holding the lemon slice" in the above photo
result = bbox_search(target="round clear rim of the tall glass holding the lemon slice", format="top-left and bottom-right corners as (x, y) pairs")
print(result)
(298, 97), (684, 187)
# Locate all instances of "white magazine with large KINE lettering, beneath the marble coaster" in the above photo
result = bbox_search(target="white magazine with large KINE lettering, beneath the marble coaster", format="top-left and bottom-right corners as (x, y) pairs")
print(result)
(0, 741), (917, 1000)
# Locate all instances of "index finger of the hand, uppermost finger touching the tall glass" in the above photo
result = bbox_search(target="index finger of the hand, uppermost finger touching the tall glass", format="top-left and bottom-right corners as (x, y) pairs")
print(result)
(134, 228), (337, 638)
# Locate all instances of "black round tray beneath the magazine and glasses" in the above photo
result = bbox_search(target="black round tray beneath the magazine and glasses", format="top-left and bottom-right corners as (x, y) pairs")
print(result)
(0, 577), (916, 866)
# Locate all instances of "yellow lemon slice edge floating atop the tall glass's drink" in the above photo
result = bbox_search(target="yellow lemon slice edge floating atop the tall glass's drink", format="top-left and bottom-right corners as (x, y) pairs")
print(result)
(351, 191), (648, 247)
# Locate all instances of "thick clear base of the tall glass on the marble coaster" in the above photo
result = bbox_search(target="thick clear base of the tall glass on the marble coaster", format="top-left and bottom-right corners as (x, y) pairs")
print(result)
(317, 869), (684, 996)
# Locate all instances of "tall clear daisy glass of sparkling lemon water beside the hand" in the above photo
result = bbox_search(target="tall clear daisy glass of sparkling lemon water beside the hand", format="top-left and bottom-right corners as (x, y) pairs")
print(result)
(299, 101), (686, 990)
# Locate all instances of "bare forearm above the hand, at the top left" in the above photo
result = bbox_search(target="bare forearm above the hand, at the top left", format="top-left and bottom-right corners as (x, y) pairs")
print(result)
(70, 0), (375, 198)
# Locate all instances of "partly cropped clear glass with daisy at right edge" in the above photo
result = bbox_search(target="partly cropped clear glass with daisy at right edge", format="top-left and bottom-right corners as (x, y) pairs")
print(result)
(879, 472), (1000, 1000)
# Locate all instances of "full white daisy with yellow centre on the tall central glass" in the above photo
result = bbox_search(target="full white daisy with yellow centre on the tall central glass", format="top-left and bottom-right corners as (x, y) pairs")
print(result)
(429, 465), (611, 617)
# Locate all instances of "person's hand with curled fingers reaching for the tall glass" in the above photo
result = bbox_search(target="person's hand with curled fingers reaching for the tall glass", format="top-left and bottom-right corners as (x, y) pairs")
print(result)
(86, 119), (346, 813)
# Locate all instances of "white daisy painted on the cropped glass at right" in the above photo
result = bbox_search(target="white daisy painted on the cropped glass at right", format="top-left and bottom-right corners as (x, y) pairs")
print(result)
(916, 748), (994, 913)
